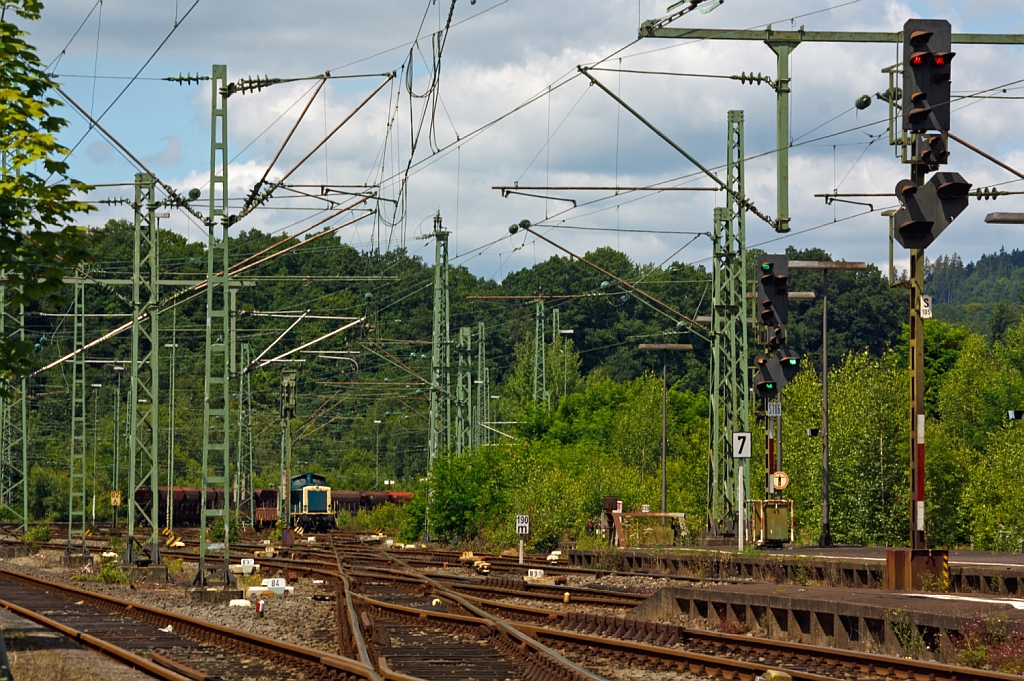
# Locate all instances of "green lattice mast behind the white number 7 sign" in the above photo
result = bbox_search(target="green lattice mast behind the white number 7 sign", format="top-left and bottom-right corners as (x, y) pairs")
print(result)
(708, 111), (750, 536)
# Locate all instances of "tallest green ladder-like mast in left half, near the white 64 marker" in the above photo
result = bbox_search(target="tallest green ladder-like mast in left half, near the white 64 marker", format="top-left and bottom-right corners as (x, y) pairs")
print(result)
(195, 65), (231, 587)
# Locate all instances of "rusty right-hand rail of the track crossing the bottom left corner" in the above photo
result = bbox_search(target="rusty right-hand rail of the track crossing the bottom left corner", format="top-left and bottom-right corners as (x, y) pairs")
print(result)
(0, 568), (381, 681)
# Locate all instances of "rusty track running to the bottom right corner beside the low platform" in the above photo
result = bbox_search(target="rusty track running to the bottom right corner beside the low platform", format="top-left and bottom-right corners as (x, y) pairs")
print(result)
(327, 536), (1019, 681)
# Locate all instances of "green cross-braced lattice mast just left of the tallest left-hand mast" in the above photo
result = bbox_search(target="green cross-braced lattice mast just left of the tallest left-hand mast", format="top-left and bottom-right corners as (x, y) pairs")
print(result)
(124, 173), (160, 565)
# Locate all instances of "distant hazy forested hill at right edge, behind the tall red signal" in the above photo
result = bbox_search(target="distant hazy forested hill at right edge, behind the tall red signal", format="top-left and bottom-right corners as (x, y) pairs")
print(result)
(926, 249), (1024, 340)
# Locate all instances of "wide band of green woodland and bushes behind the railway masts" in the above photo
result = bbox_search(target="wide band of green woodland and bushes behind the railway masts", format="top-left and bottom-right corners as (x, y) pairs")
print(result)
(26, 221), (1024, 548)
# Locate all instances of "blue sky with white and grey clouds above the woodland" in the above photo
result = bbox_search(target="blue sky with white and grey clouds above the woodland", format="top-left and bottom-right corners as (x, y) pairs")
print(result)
(25, 0), (1024, 279)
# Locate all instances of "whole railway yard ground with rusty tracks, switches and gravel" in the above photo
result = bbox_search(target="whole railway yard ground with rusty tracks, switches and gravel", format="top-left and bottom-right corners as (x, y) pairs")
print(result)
(0, 533), (1024, 681)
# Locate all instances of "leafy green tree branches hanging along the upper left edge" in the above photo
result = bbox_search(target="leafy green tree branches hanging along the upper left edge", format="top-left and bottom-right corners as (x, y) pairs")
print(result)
(0, 0), (92, 381)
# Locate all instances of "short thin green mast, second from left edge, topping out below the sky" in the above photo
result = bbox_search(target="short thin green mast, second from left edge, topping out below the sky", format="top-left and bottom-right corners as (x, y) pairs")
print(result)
(65, 278), (89, 556)
